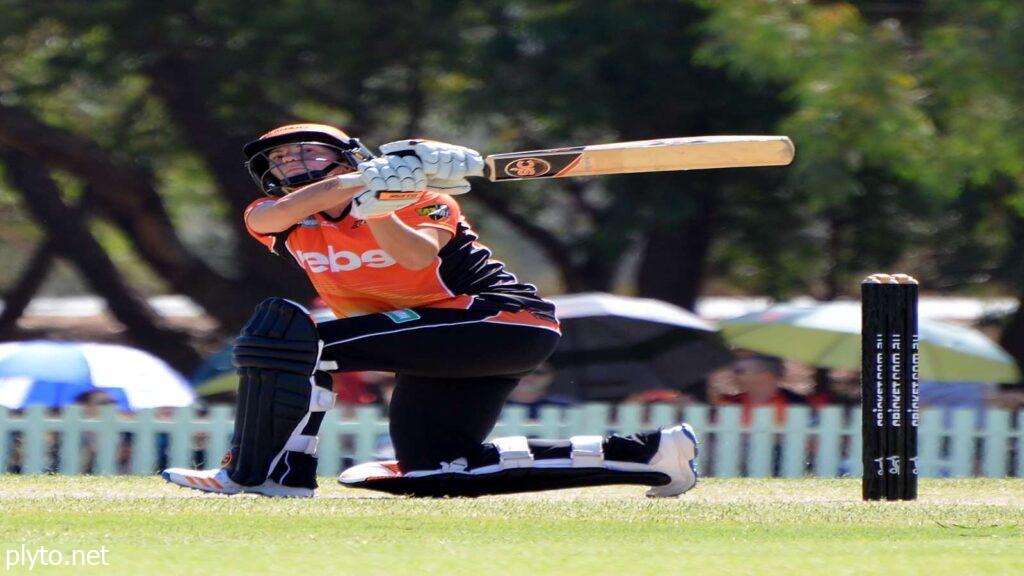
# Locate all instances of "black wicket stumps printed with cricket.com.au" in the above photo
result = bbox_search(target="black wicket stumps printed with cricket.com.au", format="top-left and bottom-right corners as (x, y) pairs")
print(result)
(860, 274), (920, 500)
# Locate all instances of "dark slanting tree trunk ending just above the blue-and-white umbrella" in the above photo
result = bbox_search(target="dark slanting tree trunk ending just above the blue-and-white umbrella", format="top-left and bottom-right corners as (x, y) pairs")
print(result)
(0, 150), (201, 371)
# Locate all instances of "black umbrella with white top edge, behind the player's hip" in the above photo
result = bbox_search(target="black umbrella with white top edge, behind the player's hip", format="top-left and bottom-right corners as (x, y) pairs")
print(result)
(551, 293), (732, 400)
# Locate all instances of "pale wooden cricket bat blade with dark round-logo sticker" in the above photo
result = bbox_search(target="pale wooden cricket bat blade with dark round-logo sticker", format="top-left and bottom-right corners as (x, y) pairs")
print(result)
(485, 136), (795, 181)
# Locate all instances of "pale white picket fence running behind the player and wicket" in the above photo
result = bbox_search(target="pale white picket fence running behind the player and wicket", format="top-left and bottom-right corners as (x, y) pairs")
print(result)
(0, 404), (1024, 478)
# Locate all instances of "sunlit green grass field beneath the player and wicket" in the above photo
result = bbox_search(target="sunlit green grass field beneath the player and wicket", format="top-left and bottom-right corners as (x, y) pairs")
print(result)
(0, 476), (1024, 576)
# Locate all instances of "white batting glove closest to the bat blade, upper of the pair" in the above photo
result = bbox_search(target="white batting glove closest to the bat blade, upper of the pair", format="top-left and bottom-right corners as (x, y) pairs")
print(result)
(381, 139), (483, 195)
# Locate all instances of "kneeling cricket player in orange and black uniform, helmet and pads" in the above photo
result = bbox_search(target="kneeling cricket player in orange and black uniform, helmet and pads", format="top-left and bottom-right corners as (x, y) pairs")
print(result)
(163, 124), (696, 497)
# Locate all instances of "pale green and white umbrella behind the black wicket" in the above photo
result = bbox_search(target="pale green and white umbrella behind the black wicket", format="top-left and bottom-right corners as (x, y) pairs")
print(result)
(721, 302), (1020, 382)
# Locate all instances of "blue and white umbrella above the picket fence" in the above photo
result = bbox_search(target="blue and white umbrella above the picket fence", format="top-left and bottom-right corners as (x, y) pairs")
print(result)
(0, 341), (195, 410)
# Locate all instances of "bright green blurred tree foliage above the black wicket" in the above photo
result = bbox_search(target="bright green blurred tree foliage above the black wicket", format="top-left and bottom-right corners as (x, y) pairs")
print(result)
(702, 0), (1024, 364)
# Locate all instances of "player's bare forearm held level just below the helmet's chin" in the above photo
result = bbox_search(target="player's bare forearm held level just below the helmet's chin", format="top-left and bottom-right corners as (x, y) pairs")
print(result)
(246, 175), (366, 234)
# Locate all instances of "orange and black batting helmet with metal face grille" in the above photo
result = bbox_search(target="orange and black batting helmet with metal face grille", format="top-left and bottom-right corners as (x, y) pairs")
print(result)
(243, 124), (374, 197)
